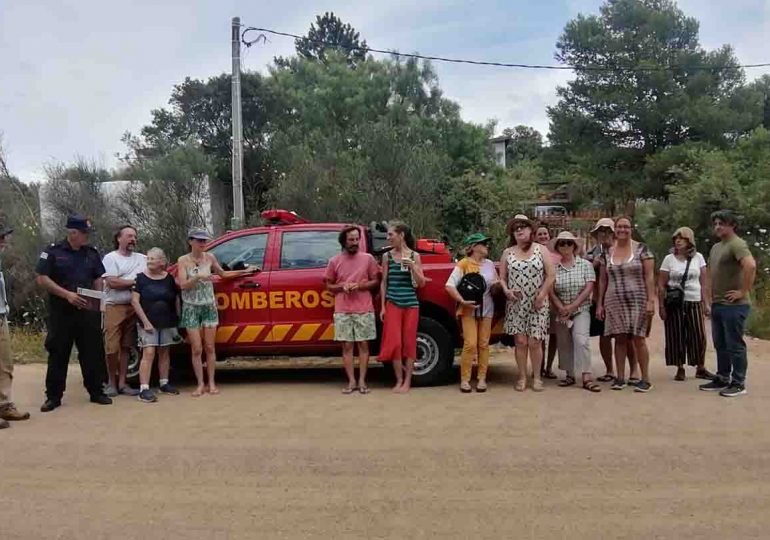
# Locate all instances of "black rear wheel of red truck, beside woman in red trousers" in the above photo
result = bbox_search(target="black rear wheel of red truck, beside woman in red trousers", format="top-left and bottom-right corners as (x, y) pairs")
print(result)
(412, 317), (454, 386)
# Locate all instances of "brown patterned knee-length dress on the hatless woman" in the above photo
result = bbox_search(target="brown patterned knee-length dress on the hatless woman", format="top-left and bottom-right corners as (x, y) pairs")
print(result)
(604, 244), (654, 337)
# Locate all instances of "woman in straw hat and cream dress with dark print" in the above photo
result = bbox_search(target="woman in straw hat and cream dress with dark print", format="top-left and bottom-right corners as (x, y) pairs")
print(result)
(500, 214), (554, 392)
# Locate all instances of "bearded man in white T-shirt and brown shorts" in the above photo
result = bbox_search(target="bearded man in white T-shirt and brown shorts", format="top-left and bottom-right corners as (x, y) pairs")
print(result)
(102, 225), (147, 397)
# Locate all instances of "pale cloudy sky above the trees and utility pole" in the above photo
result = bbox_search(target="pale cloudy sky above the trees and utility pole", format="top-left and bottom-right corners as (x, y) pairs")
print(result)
(0, 0), (770, 181)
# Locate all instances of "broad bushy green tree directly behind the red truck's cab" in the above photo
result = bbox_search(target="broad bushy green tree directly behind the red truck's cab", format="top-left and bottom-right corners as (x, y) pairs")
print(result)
(264, 55), (493, 234)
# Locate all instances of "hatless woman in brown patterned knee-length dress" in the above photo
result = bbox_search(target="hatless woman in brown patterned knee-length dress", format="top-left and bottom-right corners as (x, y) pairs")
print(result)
(596, 217), (655, 392)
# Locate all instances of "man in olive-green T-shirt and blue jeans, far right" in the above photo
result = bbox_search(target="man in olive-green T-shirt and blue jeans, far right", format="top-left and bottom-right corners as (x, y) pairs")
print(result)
(700, 210), (757, 397)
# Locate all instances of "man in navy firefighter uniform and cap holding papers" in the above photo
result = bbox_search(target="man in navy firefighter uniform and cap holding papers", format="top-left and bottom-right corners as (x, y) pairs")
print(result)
(35, 215), (112, 412)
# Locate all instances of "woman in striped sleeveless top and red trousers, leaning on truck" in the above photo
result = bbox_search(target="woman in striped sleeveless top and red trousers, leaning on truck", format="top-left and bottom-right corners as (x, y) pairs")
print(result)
(379, 221), (425, 394)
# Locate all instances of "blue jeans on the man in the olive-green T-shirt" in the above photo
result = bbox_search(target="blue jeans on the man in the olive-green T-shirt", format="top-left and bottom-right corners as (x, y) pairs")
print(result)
(711, 304), (751, 386)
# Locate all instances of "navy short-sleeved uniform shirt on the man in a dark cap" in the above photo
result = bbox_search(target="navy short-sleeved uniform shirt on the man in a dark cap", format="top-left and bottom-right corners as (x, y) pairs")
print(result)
(35, 240), (104, 302)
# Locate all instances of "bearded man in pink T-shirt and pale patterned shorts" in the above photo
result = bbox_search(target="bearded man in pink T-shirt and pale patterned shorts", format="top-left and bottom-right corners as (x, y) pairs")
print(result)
(324, 225), (380, 394)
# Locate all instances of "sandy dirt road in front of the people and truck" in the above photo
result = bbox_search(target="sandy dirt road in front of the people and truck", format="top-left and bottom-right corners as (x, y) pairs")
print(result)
(0, 322), (770, 540)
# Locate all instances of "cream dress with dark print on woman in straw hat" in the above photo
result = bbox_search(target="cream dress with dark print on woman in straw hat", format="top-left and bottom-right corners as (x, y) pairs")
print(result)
(504, 244), (550, 340)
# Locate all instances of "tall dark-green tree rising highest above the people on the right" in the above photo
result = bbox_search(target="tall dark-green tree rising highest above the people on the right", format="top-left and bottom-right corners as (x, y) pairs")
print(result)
(548, 0), (753, 208)
